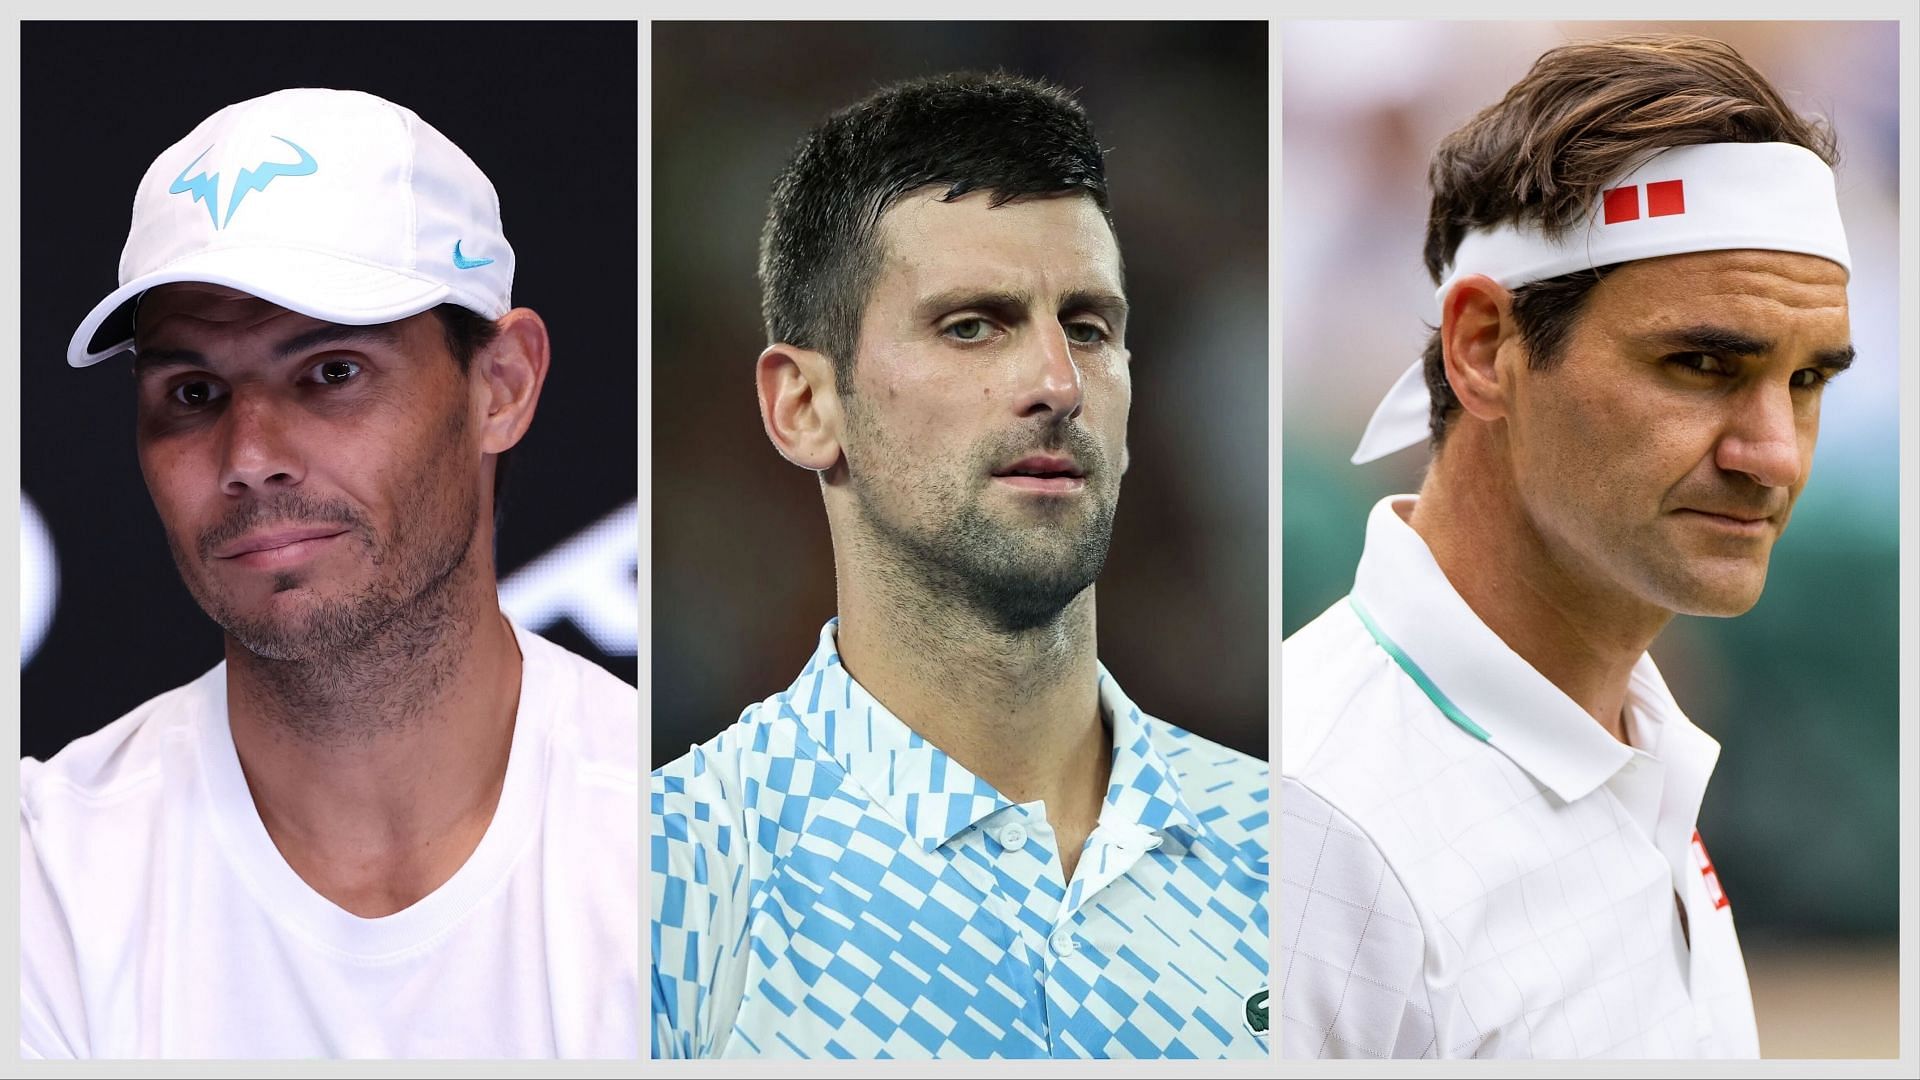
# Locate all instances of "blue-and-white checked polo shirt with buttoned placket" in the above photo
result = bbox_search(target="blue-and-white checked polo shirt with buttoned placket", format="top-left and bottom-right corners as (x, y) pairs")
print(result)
(651, 623), (1269, 1057)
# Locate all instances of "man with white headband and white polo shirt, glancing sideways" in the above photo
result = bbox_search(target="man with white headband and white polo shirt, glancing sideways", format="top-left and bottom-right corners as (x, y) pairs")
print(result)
(1279, 38), (1853, 1057)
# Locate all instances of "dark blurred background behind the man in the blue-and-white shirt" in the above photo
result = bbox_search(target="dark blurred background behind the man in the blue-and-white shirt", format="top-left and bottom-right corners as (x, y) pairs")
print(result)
(651, 23), (1269, 765)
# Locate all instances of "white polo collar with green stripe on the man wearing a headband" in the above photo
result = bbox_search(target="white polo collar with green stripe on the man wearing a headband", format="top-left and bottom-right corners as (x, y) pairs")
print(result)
(1354, 496), (1720, 809)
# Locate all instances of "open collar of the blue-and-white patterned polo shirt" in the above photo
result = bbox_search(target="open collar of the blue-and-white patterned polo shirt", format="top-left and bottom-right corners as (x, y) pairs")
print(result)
(783, 619), (1202, 851)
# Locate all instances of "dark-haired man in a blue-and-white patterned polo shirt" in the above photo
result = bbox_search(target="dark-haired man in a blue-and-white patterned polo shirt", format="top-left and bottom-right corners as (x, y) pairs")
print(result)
(653, 75), (1267, 1057)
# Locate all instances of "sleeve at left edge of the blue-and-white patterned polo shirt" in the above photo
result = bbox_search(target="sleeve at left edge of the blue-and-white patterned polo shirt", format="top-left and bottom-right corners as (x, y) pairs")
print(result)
(651, 748), (756, 1059)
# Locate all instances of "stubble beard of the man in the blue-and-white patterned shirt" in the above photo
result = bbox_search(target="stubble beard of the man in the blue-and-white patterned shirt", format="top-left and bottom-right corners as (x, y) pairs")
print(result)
(849, 407), (1117, 634)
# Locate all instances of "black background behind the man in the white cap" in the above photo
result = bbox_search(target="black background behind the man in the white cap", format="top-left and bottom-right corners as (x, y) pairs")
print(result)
(19, 23), (639, 759)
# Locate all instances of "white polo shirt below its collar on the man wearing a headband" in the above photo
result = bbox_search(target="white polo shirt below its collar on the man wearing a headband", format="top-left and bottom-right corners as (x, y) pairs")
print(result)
(1281, 603), (1728, 1057)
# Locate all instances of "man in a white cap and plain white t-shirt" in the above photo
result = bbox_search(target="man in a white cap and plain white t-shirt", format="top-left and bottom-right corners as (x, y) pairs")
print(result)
(21, 90), (639, 1057)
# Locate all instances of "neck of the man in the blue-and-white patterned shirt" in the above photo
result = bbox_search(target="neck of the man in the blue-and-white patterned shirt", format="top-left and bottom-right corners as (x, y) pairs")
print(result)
(839, 557), (1112, 878)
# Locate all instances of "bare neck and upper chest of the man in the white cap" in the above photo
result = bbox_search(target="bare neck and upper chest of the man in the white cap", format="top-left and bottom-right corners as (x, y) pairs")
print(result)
(227, 575), (520, 907)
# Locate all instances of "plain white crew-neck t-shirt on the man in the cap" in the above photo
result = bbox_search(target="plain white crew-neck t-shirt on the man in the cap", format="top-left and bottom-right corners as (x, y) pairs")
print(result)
(19, 626), (639, 1059)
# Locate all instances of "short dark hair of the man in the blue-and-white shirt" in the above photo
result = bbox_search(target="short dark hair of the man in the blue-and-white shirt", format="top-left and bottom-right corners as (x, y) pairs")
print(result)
(760, 73), (1114, 386)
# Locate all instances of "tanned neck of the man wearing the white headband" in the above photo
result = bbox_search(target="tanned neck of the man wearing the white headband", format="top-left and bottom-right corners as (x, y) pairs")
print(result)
(1407, 425), (1672, 742)
